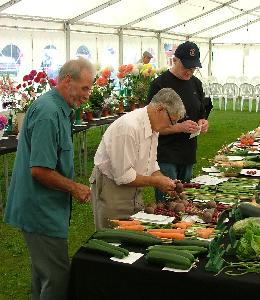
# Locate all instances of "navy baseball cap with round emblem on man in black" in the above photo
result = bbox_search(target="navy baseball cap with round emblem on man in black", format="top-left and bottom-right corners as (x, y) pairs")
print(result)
(174, 41), (202, 69)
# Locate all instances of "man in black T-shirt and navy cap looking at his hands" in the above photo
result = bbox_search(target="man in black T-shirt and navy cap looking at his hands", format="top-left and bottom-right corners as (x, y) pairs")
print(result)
(147, 41), (208, 201)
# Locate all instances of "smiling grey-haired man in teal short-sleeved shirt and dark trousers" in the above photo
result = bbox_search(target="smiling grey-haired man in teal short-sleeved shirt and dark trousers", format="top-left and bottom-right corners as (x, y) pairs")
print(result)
(5, 58), (94, 300)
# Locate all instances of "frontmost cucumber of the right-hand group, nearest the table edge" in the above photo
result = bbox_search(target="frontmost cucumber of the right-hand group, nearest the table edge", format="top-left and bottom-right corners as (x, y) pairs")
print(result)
(145, 250), (192, 270)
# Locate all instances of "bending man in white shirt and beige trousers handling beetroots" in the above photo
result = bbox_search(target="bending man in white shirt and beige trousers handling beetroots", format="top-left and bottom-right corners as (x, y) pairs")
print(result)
(90, 88), (185, 229)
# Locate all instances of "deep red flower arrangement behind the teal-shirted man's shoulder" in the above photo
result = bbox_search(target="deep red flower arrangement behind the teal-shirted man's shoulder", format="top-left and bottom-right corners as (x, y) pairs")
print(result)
(16, 70), (56, 112)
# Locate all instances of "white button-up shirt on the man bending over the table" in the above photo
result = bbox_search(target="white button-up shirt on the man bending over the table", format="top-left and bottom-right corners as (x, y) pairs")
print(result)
(94, 107), (160, 185)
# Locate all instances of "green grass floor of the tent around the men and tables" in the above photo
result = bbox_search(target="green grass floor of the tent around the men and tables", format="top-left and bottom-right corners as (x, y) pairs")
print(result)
(0, 109), (260, 300)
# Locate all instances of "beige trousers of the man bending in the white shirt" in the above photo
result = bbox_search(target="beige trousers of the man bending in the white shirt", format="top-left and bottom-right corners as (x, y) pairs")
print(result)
(89, 167), (144, 230)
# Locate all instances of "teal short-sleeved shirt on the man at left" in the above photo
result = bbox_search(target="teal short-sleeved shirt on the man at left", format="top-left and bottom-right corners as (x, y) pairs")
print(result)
(5, 89), (74, 238)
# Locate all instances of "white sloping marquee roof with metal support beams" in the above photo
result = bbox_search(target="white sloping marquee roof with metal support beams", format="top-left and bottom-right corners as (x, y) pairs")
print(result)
(0, 0), (260, 43)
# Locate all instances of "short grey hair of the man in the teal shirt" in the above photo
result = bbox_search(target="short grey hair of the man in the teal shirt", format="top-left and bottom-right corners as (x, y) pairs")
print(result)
(58, 57), (95, 81)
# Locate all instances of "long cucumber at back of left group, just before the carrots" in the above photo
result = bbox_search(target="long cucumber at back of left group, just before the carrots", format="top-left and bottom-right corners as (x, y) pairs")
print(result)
(93, 229), (162, 246)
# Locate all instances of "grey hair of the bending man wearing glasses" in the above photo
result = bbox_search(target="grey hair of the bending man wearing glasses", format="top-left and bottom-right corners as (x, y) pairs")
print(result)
(151, 88), (186, 119)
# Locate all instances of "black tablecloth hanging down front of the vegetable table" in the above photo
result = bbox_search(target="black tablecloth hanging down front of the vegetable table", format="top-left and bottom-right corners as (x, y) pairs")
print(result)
(69, 247), (260, 300)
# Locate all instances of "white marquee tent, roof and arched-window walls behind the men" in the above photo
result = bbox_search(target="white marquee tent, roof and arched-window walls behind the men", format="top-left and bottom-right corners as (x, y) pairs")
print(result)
(0, 0), (260, 82)
